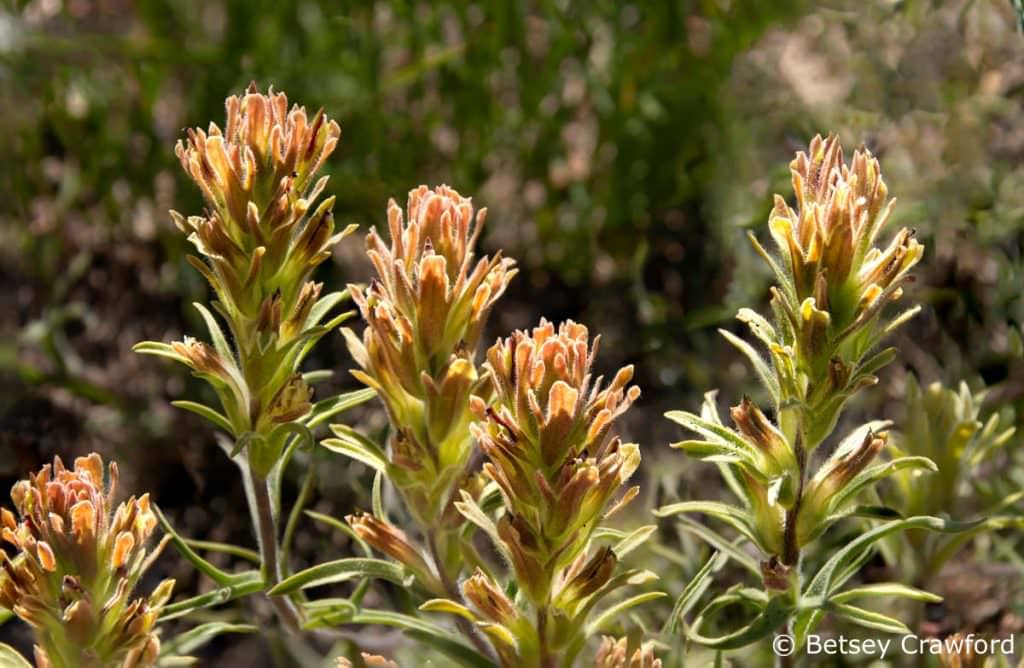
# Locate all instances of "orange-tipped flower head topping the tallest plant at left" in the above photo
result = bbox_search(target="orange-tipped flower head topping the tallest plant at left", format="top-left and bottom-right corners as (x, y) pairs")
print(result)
(171, 85), (352, 327)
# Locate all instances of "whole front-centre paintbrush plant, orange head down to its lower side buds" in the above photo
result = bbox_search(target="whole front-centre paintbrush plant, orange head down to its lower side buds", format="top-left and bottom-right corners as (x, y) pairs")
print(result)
(422, 320), (647, 666)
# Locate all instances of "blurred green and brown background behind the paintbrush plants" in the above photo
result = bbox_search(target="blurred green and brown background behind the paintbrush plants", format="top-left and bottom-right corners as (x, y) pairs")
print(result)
(0, 0), (1024, 666)
